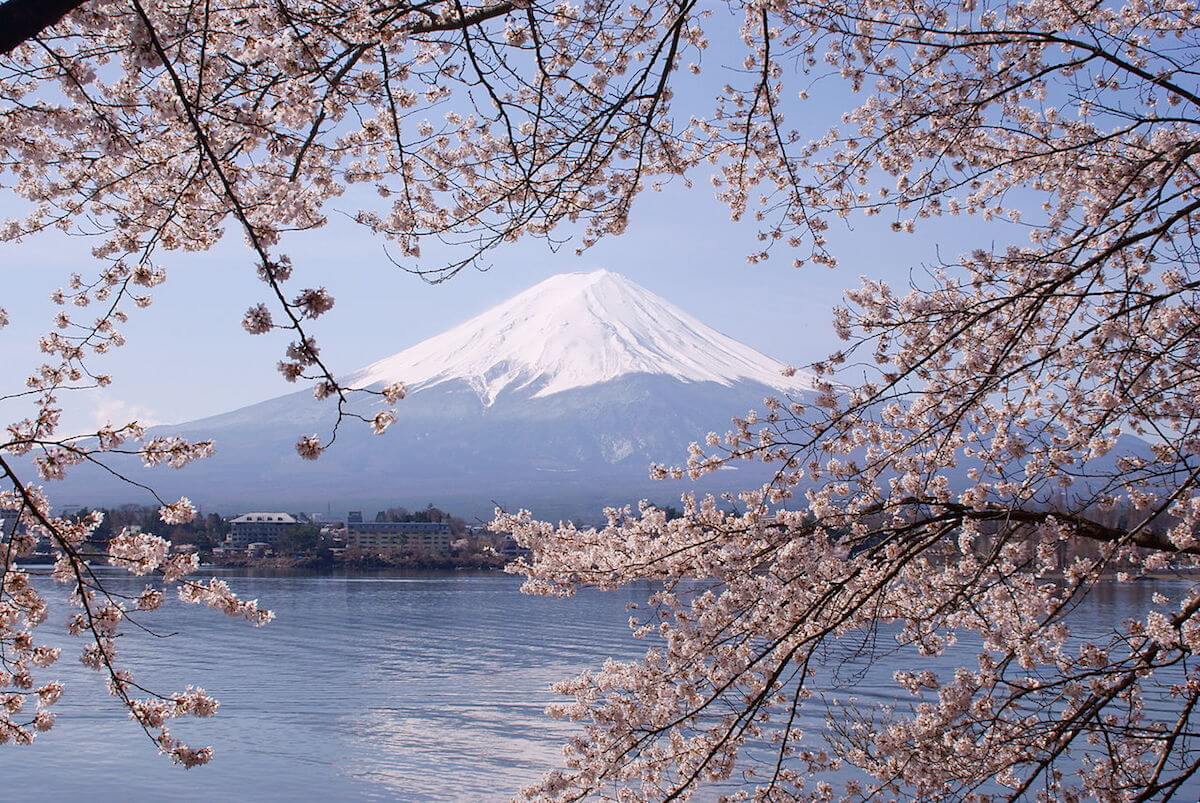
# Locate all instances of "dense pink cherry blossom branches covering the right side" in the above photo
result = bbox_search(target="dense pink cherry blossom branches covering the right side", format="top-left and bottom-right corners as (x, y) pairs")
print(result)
(497, 0), (1200, 801)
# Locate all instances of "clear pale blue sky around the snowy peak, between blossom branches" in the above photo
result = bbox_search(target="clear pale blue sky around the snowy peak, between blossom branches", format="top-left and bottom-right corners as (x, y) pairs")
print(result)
(0, 170), (1003, 426)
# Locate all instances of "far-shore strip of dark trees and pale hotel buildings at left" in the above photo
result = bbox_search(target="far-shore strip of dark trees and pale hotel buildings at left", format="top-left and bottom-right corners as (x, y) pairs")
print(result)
(0, 504), (523, 569)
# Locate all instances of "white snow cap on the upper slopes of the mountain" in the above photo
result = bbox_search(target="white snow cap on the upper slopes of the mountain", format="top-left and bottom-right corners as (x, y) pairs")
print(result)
(346, 270), (812, 405)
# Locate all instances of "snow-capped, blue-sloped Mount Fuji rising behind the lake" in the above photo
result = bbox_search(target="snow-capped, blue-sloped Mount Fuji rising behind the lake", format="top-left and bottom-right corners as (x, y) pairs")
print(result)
(55, 270), (812, 517)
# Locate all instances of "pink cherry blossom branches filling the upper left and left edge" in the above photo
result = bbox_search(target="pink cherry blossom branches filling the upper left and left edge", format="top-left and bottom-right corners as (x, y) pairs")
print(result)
(0, 0), (701, 766)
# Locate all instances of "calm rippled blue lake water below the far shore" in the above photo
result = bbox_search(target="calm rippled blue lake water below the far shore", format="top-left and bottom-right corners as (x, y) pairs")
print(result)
(9, 573), (1200, 801)
